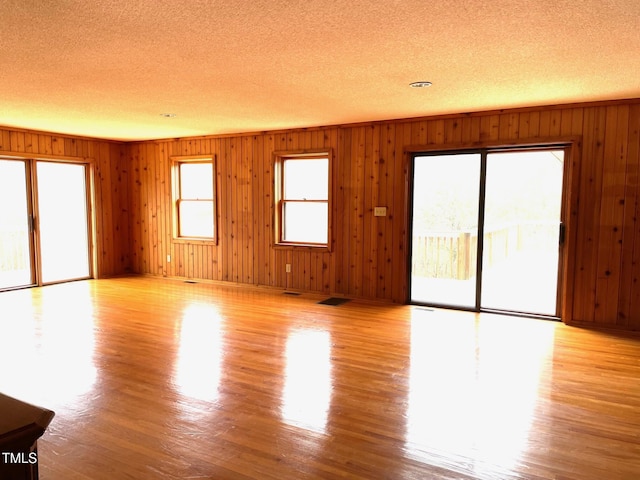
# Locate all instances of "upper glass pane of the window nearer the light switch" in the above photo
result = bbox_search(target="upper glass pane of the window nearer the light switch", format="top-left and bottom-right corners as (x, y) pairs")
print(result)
(283, 158), (329, 200)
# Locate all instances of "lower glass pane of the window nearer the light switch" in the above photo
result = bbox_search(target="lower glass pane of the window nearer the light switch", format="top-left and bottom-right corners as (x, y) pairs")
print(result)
(282, 202), (329, 244)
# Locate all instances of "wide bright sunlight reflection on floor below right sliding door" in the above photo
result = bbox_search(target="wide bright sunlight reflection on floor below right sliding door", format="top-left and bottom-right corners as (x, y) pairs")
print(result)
(406, 309), (554, 474)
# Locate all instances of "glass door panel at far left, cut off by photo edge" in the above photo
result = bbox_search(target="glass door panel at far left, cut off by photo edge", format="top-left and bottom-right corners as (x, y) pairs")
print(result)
(0, 160), (34, 289)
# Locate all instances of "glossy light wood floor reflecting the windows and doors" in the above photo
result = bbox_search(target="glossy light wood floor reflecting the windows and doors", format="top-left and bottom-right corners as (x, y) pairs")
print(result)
(0, 278), (640, 480)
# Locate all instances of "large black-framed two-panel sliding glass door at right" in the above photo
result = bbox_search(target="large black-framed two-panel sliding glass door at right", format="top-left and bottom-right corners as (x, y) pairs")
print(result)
(410, 148), (564, 317)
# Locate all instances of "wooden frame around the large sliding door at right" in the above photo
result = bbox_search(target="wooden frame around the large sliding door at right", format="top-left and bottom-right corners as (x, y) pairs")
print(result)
(403, 136), (582, 322)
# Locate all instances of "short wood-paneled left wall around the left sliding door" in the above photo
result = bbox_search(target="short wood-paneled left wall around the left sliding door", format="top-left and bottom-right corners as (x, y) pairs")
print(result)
(0, 128), (131, 277)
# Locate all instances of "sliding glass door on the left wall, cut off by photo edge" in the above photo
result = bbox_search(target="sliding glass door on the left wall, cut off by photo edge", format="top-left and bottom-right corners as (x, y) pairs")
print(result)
(0, 158), (91, 290)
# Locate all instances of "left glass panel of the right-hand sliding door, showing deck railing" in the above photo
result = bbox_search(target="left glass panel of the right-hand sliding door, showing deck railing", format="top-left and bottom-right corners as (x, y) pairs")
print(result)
(411, 153), (481, 308)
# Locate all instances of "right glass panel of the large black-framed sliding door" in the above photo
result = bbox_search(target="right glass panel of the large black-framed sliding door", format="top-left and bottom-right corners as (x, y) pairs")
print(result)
(481, 150), (564, 316)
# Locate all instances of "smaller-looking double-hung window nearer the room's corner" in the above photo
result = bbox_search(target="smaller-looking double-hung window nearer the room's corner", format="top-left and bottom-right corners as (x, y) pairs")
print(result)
(173, 157), (215, 240)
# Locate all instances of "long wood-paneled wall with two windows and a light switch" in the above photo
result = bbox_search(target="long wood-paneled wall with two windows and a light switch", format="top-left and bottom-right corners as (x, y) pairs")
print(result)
(127, 100), (640, 329)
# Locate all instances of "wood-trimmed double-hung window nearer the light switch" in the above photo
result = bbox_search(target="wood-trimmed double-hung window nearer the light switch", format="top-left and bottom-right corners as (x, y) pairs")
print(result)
(275, 151), (329, 247)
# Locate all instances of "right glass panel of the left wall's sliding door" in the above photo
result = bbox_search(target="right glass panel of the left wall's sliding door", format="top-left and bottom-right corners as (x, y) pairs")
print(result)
(36, 161), (90, 283)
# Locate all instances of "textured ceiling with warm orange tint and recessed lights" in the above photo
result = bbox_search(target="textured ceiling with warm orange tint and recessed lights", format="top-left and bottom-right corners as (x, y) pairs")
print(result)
(0, 0), (640, 140)
